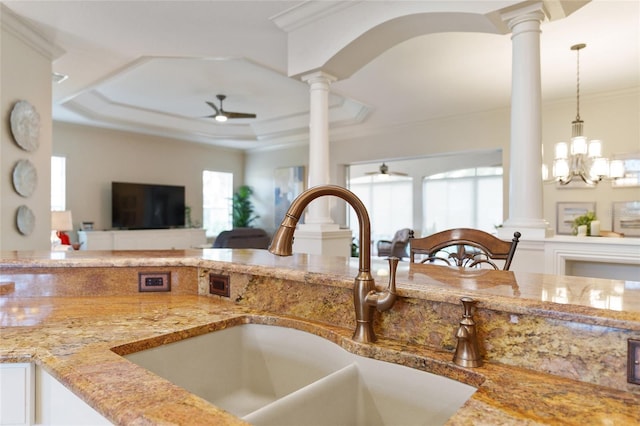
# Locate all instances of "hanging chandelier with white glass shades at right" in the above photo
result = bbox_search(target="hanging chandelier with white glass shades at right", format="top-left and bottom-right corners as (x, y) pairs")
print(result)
(542, 43), (624, 185)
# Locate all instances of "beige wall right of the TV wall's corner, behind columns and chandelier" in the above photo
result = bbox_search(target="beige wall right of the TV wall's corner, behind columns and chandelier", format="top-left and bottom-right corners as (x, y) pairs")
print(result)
(246, 88), (640, 238)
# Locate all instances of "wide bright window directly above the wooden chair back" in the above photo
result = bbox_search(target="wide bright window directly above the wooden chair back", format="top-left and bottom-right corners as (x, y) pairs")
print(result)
(422, 167), (502, 235)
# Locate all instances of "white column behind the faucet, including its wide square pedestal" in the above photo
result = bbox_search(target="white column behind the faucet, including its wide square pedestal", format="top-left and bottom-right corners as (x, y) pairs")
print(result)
(293, 71), (351, 257)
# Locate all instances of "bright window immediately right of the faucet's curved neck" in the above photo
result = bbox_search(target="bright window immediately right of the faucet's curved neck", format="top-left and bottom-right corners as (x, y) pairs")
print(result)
(348, 175), (413, 251)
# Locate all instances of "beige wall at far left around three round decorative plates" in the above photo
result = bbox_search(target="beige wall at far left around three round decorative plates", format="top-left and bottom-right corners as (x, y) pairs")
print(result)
(0, 11), (51, 250)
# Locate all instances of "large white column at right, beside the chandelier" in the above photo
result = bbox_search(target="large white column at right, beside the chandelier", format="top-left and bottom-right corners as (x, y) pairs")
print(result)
(499, 3), (549, 239)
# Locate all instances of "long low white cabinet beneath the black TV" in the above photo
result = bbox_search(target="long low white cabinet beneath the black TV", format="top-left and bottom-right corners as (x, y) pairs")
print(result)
(78, 228), (207, 250)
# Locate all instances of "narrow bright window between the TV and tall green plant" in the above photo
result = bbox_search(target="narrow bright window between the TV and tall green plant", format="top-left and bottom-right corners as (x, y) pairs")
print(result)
(202, 170), (233, 237)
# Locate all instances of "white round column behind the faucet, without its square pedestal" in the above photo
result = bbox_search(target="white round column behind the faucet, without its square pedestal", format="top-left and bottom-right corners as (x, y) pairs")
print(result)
(302, 71), (336, 228)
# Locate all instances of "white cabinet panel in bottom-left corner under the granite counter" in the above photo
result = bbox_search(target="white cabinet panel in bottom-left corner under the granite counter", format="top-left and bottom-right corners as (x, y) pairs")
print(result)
(0, 363), (35, 426)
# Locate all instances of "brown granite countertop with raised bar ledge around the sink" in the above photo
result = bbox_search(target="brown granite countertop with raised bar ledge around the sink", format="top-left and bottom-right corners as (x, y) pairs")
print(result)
(0, 249), (640, 425)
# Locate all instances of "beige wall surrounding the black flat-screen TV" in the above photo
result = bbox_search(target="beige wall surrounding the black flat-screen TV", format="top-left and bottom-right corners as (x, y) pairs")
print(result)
(53, 122), (244, 238)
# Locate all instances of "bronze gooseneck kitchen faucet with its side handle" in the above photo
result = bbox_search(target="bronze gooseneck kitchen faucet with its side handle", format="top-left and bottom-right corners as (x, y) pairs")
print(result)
(269, 185), (397, 342)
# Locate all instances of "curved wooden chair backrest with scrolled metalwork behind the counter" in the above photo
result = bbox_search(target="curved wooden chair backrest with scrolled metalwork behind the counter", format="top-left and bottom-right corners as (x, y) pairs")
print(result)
(409, 228), (520, 271)
